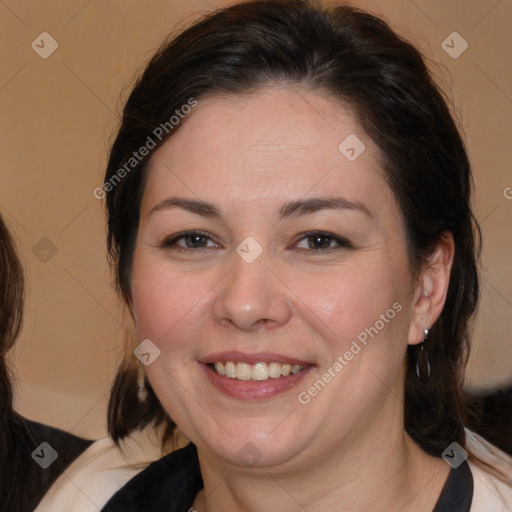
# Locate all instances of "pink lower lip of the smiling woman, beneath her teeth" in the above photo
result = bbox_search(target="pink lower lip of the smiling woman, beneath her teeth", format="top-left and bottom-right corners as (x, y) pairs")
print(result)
(201, 363), (314, 400)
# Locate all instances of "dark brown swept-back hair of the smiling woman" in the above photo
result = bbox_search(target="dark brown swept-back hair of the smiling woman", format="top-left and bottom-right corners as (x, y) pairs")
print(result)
(105, 0), (479, 455)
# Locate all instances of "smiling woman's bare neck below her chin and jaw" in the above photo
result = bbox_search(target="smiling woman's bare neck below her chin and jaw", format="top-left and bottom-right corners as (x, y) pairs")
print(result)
(194, 384), (449, 512)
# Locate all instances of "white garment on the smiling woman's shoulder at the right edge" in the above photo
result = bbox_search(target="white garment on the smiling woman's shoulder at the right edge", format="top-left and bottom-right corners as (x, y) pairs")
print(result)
(466, 429), (512, 512)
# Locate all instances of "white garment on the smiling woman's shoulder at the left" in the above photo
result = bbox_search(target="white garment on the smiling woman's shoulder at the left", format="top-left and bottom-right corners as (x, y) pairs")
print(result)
(35, 428), (162, 512)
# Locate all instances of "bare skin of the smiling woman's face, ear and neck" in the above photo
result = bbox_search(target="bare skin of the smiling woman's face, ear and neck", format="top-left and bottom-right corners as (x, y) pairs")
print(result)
(130, 86), (453, 512)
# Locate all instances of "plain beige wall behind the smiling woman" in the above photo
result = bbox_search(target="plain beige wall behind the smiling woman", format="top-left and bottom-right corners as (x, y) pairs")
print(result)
(0, 0), (512, 437)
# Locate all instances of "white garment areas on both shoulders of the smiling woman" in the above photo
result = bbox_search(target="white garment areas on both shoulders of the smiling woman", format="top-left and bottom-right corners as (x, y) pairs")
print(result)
(35, 429), (512, 512)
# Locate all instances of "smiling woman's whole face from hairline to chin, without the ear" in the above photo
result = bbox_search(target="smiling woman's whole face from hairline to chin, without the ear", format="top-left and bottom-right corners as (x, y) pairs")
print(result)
(131, 86), (428, 467)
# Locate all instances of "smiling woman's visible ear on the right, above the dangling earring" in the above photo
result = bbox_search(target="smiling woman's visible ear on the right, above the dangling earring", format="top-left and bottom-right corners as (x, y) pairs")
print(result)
(409, 233), (455, 345)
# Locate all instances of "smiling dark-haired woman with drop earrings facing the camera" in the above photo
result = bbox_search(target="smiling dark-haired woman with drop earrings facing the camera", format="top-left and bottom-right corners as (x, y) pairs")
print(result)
(98, 0), (512, 512)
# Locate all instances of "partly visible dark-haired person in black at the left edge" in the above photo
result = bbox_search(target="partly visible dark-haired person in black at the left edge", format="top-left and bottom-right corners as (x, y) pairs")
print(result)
(0, 216), (90, 512)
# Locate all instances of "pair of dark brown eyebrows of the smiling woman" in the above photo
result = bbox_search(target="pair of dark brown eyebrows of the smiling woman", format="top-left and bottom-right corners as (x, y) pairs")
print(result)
(149, 197), (374, 219)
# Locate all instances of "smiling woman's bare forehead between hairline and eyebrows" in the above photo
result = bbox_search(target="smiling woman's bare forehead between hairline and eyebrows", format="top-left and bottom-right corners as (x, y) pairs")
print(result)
(143, 86), (388, 216)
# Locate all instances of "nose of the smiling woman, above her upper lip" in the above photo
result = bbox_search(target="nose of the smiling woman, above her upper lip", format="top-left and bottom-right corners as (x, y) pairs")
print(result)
(214, 255), (292, 332)
